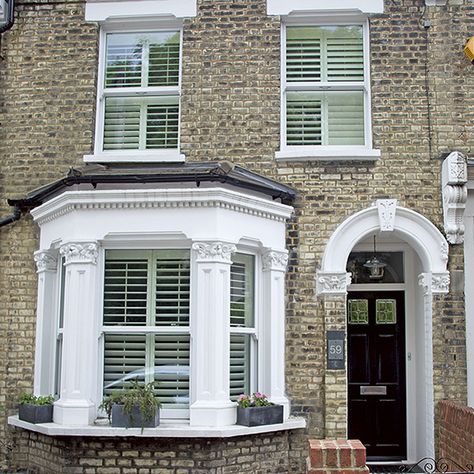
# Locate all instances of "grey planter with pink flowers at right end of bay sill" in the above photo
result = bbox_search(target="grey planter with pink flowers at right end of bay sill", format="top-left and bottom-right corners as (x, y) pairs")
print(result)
(237, 392), (283, 426)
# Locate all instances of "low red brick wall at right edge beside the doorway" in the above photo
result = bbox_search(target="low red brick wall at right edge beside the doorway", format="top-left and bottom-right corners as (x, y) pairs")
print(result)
(437, 400), (474, 471)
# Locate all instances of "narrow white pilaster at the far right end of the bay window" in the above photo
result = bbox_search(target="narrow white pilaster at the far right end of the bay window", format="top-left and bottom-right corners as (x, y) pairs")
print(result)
(259, 250), (290, 420)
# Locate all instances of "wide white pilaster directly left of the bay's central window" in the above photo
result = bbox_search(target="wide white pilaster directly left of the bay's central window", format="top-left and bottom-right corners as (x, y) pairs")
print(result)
(54, 242), (99, 425)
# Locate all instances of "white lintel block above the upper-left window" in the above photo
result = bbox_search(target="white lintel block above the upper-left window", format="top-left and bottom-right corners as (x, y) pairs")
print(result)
(85, 0), (197, 22)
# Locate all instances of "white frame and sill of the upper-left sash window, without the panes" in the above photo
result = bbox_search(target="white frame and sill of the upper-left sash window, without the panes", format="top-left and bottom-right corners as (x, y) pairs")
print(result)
(84, 21), (185, 163)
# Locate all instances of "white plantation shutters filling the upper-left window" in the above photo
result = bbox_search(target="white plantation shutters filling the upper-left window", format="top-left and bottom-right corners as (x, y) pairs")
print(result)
(102, 31), (180, 151)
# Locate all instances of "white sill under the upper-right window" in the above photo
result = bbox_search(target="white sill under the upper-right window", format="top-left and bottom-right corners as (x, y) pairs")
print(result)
(275, 146), (380, 161)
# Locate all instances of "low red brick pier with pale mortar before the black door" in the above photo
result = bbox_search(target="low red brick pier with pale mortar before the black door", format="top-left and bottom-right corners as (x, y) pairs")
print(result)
(307, 439), (369, 474)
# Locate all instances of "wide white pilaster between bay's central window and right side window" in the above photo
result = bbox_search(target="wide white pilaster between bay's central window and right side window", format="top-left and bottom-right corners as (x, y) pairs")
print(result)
(190, 242), (236, 426)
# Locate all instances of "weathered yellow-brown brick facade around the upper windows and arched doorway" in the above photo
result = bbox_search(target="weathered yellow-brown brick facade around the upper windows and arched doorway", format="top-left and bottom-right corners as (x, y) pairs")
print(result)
(0, 0), (474, 473)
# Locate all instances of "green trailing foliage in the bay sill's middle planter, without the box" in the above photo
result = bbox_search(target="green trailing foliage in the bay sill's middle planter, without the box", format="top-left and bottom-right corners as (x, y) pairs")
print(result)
(99, 380), (160, 429)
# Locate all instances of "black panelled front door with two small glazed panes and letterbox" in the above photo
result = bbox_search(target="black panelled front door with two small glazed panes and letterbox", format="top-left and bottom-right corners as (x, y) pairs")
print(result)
(347, 291), (407, 460)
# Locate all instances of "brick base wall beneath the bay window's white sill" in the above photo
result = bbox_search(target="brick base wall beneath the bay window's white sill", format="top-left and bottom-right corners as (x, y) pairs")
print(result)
(8, 429), (305, 474)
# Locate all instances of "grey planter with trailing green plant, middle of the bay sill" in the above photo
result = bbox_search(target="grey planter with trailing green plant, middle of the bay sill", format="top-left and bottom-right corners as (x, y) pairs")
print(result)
(99, 380), (160, 431)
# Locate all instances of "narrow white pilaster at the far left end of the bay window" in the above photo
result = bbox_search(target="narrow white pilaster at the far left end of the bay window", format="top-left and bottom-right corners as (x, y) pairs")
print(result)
(33, 250), (58, 395)
